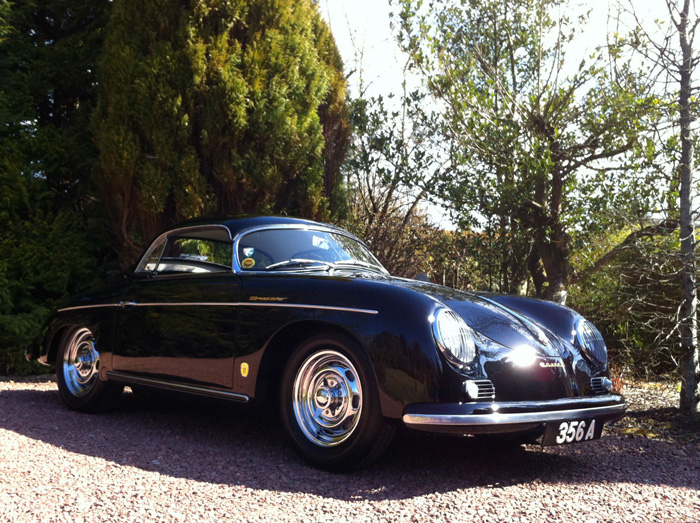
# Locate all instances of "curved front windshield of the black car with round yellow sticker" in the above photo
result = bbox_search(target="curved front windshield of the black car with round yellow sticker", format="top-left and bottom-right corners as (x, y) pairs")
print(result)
(237, 229), (385, 272)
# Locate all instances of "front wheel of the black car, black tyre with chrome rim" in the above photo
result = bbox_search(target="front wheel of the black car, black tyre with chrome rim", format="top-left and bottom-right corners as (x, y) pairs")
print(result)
(281, 333), (395, 471)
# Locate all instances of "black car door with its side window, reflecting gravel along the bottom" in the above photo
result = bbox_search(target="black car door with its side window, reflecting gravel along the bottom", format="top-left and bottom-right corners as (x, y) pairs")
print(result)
(113, 227), (241, 388)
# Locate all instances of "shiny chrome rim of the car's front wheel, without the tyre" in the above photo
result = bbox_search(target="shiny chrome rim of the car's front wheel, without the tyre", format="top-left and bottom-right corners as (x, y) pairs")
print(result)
(293, 350), (362, 447)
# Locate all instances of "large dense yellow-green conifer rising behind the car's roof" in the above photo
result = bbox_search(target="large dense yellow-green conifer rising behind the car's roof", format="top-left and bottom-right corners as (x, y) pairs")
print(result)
(94, 0), (347, 264)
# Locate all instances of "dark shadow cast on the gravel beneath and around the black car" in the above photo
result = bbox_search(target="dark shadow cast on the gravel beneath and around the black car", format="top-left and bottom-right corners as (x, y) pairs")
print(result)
(0, 386), (700, 501)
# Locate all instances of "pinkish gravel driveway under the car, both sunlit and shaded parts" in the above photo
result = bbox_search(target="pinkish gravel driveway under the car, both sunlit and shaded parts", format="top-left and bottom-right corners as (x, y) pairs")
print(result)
(0, 378), (700, 523)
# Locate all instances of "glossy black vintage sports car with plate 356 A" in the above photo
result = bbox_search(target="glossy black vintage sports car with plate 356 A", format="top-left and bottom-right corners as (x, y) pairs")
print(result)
(27, 217), (626, 470)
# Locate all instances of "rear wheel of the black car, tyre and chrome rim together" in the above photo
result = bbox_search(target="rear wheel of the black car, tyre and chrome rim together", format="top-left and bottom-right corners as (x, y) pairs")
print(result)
(56, 327), (124, 412)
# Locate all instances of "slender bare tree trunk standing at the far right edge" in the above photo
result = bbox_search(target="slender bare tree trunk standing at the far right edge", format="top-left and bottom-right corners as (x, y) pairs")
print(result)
(677, 0), (700, 417)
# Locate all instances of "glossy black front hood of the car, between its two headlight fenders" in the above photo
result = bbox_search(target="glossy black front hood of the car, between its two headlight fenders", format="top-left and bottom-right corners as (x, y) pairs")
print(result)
(382, 278), (566, 357)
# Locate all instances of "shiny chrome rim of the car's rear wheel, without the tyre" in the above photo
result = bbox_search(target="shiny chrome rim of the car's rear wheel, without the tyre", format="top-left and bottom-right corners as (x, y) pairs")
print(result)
(63, 329), (100, 396)
